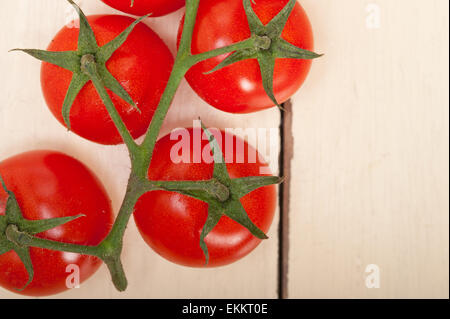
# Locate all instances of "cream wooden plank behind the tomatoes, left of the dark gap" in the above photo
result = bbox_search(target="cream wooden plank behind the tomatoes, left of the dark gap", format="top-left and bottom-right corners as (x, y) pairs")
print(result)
(0, 0), (280, 299)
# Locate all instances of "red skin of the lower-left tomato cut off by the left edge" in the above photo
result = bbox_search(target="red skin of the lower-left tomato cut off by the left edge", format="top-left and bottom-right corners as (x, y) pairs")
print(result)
(0, 151), (113, 296)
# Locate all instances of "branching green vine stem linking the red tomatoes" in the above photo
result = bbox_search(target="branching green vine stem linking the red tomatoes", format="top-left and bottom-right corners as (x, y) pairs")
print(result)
(0, 0), (322, 291)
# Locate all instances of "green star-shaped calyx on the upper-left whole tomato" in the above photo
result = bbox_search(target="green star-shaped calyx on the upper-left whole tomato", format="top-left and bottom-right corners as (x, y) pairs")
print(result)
(11, 0), (149, 149)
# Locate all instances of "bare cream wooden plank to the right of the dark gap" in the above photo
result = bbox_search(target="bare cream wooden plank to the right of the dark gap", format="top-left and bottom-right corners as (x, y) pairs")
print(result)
(288, 0), (449, 298)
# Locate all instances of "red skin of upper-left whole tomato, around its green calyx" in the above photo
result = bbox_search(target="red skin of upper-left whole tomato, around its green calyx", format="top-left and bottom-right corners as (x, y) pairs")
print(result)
(41, 15), (173, 145)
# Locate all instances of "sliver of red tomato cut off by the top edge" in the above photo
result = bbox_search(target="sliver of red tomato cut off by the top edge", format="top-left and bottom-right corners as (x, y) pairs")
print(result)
(102, 0), (185, 17)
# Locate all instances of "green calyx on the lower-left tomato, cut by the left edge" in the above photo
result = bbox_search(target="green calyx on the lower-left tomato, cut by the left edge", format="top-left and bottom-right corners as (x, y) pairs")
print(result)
(0, 176), (84, 291)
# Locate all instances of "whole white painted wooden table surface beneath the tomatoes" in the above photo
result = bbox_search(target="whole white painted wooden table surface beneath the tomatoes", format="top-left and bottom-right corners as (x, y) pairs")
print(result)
(0, 0), (449, 299)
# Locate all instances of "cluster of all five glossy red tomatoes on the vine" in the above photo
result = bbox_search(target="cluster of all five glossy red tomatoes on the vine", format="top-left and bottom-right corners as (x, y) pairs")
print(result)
(0, 0), (313, 296)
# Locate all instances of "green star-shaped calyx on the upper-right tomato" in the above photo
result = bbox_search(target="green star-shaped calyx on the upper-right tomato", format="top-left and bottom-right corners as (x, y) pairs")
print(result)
(206, 0), (322, 108)
